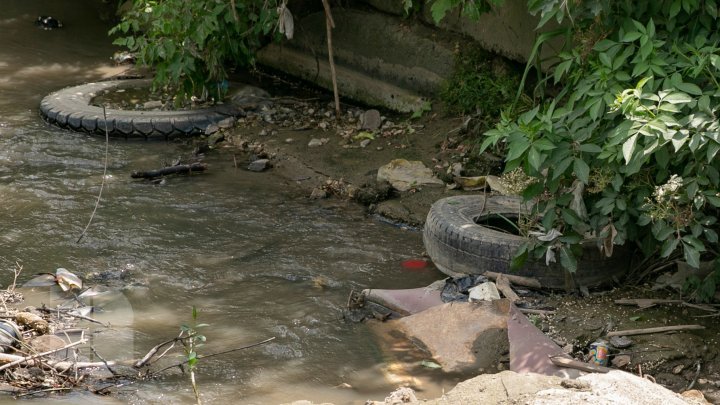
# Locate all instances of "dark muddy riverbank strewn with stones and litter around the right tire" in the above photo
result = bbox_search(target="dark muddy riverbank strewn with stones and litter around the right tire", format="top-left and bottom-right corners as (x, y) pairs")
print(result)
(215, 83), (720, 402)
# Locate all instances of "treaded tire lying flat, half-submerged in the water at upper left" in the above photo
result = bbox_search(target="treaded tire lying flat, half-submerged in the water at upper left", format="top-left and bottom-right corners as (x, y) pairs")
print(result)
(40, 79), (243, 139)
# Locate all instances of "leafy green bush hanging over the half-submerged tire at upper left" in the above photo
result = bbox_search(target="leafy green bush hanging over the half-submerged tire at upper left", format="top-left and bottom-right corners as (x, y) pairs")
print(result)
(110, 0), (278, 101)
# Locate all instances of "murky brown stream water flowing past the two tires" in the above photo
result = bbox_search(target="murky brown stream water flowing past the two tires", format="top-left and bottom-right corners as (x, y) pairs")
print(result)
(0, 0), (448, 404)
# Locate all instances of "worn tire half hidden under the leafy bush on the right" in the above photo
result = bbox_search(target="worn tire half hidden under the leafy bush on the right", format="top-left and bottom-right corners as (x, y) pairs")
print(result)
(423, 195), (630, 289)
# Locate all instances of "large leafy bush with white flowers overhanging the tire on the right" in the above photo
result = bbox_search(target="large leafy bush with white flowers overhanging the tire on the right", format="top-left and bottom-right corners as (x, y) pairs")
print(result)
(483, 0), (720, 299)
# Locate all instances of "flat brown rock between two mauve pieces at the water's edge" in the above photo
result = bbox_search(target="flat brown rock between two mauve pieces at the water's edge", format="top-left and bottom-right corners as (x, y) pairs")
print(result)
(391, 300), (510, 373)
